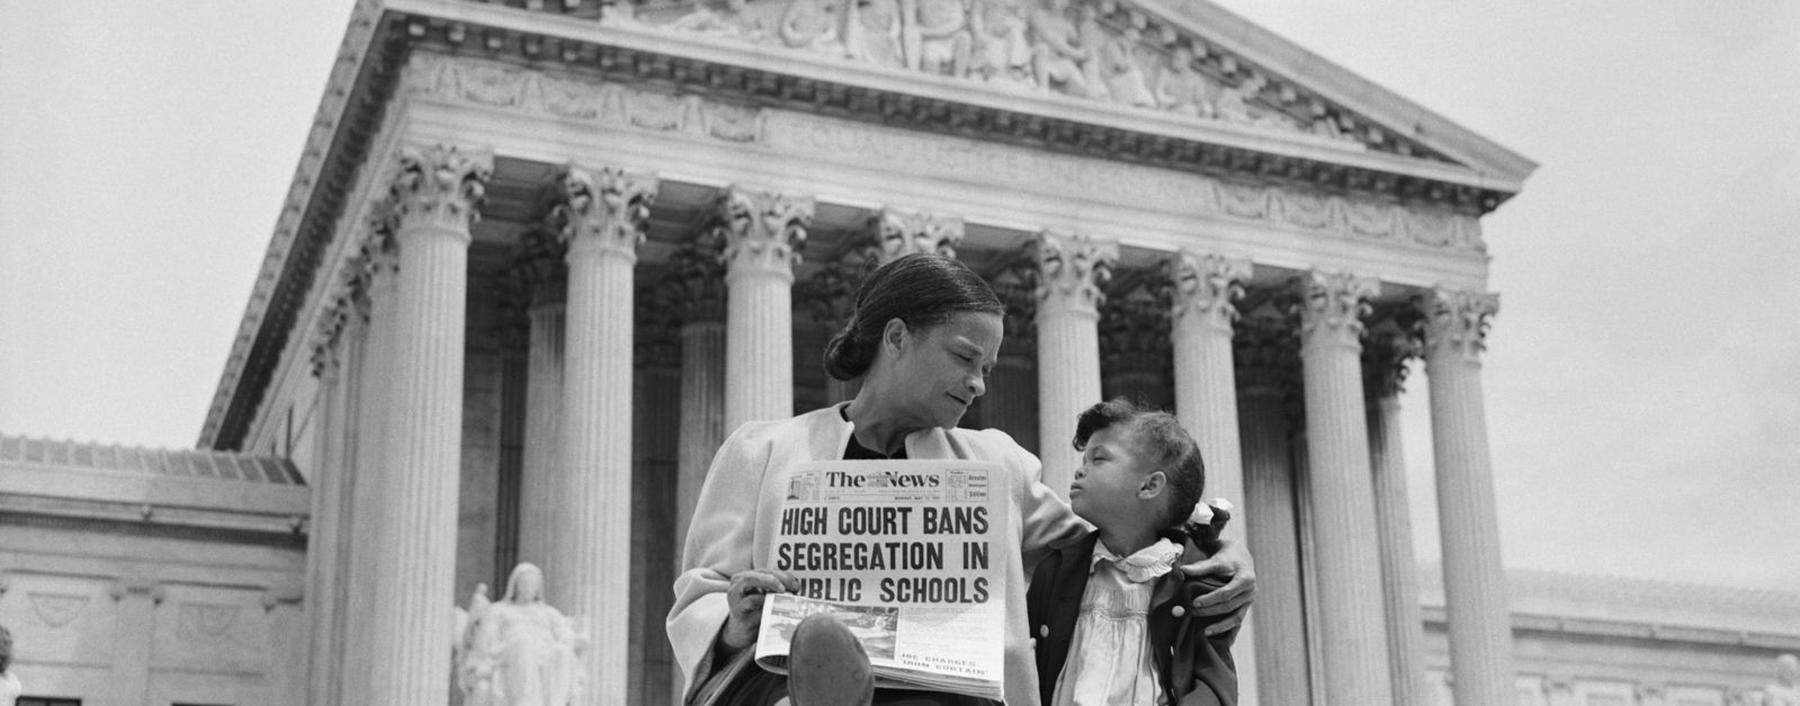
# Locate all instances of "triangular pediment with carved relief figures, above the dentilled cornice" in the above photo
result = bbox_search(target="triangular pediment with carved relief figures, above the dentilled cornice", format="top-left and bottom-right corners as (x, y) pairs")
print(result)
(601, 0), (1535, 184)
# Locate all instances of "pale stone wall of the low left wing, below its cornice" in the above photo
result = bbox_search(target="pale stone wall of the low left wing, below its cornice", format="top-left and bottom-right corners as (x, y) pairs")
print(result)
(0, 519), (306, 706)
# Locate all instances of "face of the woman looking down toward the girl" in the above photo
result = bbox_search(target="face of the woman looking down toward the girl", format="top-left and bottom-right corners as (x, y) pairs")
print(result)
(884, 312), (1003, 429)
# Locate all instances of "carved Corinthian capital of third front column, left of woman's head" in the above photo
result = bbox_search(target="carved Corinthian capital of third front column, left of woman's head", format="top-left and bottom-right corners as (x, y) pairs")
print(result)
(718, 187), (814, 281)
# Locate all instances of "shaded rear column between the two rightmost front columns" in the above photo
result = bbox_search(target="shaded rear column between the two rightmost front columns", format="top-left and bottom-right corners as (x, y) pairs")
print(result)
(1363, 313), (1431, 706)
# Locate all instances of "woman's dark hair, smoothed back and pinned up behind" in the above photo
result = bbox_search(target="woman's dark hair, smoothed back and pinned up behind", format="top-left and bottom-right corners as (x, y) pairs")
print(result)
(824, 254), (1006, 380)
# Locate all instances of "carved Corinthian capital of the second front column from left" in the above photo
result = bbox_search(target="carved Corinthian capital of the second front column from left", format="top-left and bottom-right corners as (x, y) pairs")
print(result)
(551, 166), (657, 261)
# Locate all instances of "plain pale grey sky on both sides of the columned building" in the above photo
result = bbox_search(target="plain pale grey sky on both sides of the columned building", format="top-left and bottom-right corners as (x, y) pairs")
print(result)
(0, 0), (1800, 591)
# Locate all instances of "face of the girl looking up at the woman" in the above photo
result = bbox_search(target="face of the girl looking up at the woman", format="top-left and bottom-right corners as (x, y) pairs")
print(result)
(1069, 427), (1161, 529)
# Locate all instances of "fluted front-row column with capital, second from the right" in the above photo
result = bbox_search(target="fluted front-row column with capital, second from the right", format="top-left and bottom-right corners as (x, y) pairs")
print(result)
(1296, 270), (1393, 704)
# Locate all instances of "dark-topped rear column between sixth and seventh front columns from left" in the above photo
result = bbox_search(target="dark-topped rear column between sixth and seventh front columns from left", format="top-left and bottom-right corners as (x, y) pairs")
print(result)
(1231, 312), (1310, 706)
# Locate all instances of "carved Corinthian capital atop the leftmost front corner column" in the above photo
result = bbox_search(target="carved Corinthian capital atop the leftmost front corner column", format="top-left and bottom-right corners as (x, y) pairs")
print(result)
(389, 144), (493, 232)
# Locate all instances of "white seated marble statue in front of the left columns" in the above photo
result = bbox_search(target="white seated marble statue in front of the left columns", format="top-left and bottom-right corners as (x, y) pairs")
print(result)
(457, 564), (587, 706)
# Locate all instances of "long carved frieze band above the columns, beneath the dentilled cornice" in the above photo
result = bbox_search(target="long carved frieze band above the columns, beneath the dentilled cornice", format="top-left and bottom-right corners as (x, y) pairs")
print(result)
(407, 54), (1483, 252)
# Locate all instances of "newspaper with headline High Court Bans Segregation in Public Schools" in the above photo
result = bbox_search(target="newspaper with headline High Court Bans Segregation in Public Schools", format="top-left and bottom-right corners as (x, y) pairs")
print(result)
(756, 461), (1017, 701)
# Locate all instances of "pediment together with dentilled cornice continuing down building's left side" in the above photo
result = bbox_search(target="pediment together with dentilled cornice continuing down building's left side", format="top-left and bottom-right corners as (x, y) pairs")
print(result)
(200, 0), (1535, 448)
